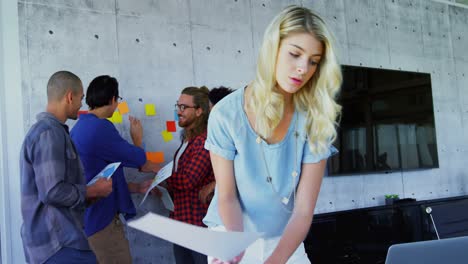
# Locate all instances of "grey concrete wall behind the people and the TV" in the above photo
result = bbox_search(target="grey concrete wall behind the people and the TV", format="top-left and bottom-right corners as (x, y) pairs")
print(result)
(18, 0), (468, 263)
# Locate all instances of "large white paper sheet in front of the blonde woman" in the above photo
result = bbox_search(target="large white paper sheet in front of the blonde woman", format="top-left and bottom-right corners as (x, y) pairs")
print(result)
(128, 213), (260, 261)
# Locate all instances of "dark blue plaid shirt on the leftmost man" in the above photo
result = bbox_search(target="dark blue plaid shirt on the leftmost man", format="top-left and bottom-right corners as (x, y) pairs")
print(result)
(20, 113), (90, 263)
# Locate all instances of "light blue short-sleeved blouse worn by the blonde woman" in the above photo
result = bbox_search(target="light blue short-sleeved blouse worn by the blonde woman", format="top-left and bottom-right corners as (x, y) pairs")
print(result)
(203, 89), (337, 237)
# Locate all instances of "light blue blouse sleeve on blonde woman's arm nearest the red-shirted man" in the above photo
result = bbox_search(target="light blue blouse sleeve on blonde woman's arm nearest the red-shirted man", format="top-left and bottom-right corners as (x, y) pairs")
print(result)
(205, 106), (236, 160)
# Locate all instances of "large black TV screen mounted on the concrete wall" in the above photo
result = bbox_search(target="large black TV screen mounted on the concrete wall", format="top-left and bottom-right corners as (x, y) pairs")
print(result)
(328, 66), (439, 175)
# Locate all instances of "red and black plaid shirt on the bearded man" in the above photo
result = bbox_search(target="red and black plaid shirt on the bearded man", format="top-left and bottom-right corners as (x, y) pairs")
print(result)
(167, 132), (214, 226)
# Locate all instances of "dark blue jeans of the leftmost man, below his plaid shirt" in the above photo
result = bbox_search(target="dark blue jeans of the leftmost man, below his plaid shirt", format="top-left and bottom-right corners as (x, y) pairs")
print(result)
(44, 247), (97, 264)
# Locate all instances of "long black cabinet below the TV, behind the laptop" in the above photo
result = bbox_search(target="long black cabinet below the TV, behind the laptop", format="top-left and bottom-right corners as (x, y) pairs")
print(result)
(304, 196), (468, 264)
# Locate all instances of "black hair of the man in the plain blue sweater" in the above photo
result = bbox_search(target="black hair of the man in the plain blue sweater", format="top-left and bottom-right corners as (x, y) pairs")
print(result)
(86, 75), (119, 110)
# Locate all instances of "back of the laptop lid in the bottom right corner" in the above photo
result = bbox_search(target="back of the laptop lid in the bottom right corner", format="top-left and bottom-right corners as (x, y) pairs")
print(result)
(385, 236), (468, 264)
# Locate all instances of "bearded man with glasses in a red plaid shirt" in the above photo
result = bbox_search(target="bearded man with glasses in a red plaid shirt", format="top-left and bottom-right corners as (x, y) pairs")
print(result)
(167, 87), (214, 264)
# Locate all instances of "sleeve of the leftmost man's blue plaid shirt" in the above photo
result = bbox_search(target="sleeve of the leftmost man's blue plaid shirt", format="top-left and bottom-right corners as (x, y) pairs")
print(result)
(33, 130), (86, 207)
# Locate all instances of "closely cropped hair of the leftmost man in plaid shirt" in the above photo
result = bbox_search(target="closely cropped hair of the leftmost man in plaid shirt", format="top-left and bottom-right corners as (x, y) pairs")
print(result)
(47, 71), (82, 102)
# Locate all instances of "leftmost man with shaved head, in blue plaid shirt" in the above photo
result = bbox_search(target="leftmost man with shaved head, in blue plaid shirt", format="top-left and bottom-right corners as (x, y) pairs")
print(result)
(20, 71), (112, 263)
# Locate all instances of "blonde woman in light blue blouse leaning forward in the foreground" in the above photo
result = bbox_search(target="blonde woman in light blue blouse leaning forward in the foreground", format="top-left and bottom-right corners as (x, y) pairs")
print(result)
(204, 6), (342, 263)
